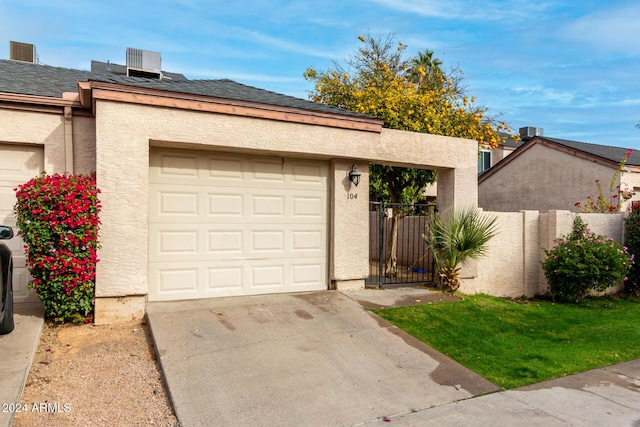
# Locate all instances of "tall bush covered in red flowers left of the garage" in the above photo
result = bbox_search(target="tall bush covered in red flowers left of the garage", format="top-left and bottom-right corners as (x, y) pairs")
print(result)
(14, 174), (100, 323)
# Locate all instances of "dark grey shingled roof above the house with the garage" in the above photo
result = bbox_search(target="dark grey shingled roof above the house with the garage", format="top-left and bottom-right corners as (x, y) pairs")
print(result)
(0, 60), (370, 118)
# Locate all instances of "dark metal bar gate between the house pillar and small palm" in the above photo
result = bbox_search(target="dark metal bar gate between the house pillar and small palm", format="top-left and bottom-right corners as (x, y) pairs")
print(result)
(366, 202), (436, 287)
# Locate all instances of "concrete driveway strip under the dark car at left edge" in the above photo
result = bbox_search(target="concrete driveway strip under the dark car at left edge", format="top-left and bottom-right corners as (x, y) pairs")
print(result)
(0, 303), (44, 426)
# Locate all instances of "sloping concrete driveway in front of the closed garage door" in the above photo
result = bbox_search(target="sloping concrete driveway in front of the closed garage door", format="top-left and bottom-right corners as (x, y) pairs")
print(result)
(147, 291), (498, 427)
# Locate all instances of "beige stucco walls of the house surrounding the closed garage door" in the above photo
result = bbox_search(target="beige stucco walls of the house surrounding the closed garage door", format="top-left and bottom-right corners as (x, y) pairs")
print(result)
(0, 84), (477, 323)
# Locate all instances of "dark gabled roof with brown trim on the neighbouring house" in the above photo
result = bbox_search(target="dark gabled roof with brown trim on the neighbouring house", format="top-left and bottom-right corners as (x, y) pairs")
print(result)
(478, 136), (640, 183)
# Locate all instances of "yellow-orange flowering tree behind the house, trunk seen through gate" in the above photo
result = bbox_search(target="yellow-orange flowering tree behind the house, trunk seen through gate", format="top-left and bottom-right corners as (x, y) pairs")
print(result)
(304, 31), (517, 276)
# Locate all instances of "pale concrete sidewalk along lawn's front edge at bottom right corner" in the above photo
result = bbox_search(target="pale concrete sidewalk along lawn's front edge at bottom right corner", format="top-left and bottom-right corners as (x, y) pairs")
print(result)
(363, 360), (640, 427)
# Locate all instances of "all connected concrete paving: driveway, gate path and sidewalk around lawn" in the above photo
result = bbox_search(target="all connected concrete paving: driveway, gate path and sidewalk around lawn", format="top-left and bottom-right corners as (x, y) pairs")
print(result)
(147, 289), (640, 427)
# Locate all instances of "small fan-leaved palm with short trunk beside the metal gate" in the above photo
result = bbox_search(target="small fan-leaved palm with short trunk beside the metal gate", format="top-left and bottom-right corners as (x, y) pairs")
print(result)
(424, 207), (497, 291)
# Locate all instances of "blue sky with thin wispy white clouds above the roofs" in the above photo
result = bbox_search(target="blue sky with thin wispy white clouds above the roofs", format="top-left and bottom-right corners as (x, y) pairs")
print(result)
(0, 0), (640, 149)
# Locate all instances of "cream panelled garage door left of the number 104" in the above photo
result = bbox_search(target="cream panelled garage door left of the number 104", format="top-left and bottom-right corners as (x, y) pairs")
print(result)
(149, 149), (328, 301)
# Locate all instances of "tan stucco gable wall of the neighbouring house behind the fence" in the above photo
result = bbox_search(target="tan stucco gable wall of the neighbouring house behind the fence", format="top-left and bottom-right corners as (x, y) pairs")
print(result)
(478, 144), (615, 212)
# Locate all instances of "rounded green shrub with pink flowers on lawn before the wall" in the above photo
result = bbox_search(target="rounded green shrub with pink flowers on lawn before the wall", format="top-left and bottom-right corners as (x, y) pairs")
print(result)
(542, 215), (634, 302)
